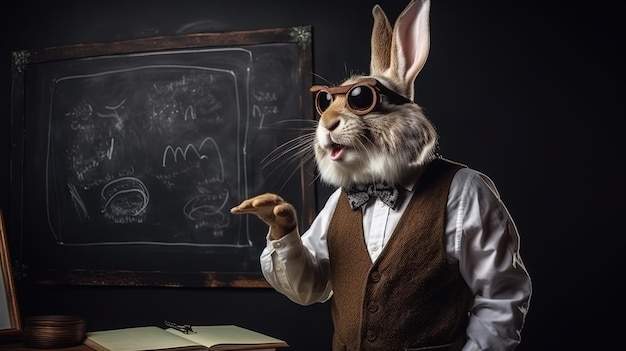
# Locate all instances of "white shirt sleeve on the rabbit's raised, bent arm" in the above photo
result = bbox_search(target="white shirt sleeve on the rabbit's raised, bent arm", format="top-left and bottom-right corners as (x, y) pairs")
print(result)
(260, 189), (341, 305)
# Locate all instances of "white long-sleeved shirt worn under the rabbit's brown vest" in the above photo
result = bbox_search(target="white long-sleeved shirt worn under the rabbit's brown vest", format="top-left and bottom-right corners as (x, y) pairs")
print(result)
(260, 168), (532, 351)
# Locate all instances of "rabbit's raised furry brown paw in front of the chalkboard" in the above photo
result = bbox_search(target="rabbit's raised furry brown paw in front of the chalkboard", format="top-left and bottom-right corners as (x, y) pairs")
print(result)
(230, 193), (298, 240)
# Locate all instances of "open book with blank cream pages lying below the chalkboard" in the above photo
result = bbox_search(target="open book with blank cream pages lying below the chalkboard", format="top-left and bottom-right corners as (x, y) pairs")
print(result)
(84, 325), (289, 351)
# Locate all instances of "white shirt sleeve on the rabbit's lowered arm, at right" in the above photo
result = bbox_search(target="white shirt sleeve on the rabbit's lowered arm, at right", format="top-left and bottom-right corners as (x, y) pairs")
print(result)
(448, 169), (532, 351)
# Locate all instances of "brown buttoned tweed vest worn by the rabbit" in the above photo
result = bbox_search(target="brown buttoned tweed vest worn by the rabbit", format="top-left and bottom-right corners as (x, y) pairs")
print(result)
(328, 159), (471, 351)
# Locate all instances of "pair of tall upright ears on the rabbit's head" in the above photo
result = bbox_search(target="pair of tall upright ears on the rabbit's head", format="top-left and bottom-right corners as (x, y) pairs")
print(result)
(370, 0), (430, 99)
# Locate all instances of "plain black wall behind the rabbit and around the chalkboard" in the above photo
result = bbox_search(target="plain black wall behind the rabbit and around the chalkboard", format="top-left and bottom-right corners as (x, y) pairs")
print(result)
(0, 0), (626, 350)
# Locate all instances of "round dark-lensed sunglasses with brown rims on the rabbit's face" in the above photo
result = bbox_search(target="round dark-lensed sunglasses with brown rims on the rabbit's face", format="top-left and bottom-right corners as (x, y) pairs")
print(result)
(310, 78), (413, 116)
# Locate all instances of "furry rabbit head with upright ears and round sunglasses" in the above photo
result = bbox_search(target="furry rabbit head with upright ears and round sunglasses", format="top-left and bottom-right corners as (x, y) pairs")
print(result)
(311, 0), (438, 187)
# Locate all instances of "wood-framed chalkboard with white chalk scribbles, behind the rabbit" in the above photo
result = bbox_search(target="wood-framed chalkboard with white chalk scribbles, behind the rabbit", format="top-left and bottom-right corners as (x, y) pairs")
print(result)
(11, 26), (316, 288)
